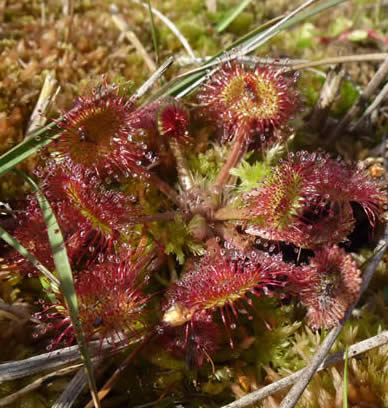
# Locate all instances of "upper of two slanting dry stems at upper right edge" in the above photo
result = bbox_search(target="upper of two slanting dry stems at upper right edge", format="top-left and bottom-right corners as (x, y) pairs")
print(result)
(327, 54), (388, 143)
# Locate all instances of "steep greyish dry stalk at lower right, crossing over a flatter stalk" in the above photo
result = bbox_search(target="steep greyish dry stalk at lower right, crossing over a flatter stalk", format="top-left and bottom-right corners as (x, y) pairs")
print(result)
(279, 223), (388, 408)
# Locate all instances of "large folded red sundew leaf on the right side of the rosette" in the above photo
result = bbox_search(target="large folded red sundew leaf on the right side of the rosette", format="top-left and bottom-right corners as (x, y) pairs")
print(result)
(243, 152), (386, 248)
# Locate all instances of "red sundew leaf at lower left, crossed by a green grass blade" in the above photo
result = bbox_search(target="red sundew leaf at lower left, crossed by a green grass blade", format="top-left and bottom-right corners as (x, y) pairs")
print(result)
(38, 258), (150, 346)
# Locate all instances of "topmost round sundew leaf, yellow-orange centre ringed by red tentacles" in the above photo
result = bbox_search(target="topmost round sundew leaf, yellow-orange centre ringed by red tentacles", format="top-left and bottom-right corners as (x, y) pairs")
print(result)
(198, 62), (299, 143)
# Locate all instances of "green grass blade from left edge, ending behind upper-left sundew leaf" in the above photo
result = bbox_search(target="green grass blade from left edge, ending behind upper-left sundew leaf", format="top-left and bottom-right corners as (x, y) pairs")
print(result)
(0, 123), (57, 177)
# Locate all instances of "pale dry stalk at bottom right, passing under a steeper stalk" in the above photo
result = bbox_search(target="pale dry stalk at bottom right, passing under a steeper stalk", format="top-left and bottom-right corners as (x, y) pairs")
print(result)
(223, 331), (388, 408)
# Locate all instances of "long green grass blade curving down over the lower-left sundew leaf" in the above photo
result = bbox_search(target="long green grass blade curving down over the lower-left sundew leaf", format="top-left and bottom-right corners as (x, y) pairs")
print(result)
(15, 170), (100, 408)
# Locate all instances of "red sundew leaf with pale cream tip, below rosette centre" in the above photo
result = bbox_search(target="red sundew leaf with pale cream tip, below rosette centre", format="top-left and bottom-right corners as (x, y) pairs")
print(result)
(162, 252), (293, 347)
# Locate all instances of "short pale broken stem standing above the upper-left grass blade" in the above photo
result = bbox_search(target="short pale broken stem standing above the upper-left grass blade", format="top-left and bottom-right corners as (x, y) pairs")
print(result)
(25, 72), (60, 138)
